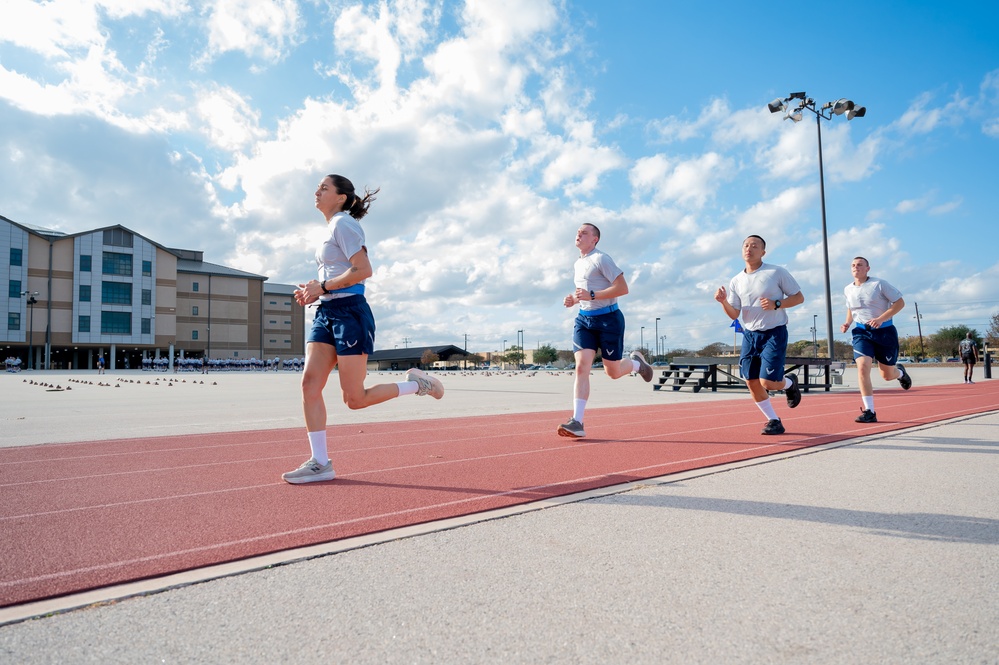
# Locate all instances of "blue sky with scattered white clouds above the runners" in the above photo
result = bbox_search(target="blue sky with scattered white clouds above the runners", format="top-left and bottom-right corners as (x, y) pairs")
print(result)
(0, 0), (999, 351)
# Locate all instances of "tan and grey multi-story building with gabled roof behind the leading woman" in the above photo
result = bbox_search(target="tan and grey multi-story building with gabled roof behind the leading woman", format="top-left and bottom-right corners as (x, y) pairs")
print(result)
(0, 215), (305, 369)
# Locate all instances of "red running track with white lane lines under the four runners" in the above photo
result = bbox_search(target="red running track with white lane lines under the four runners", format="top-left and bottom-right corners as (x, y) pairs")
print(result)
(0, 382), (999, 607)
